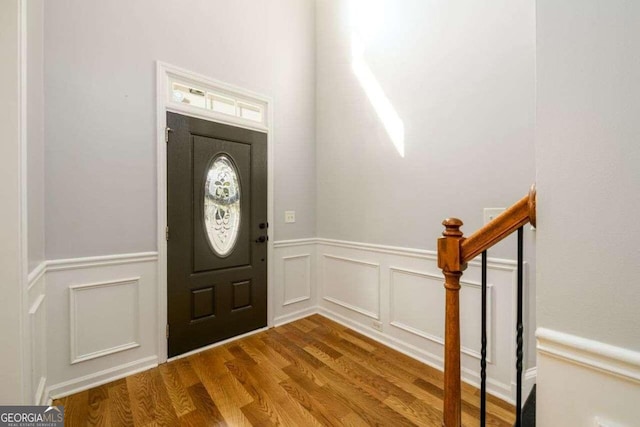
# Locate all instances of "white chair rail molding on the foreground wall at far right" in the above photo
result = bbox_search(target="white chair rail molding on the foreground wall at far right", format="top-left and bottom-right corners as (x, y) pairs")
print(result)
(536, 328), (640, 383)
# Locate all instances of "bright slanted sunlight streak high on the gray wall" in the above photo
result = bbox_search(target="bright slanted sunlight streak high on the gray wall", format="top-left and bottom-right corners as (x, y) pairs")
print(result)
(350, 0), (404, 157)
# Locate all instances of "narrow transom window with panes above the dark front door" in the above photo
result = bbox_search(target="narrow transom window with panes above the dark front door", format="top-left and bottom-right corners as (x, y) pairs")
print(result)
(168, 78), (266, 124)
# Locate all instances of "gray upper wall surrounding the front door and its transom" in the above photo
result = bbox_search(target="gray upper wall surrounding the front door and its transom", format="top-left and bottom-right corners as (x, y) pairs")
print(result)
(44, 0), (316, 259)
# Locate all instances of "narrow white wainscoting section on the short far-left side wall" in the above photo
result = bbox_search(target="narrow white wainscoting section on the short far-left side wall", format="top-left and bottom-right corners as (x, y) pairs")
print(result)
(25, 262), (47, 405)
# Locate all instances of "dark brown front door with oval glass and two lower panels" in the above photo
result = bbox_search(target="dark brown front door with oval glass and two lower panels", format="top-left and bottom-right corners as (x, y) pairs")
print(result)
(167, 113), (267, 357)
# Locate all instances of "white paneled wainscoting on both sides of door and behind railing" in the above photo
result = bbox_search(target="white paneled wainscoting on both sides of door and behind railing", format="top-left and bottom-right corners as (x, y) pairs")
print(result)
(29, 239), (535, 402)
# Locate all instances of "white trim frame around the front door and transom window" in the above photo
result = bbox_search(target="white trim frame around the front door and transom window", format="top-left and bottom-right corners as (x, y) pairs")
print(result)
(156, 61), (275, 363)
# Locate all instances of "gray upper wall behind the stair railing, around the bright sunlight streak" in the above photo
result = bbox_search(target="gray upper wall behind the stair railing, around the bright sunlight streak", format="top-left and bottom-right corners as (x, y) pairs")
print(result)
(316, 0), (536, 366)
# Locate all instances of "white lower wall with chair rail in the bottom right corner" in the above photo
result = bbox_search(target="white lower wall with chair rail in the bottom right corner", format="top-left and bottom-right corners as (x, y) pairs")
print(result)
(536, 328), (640, 427)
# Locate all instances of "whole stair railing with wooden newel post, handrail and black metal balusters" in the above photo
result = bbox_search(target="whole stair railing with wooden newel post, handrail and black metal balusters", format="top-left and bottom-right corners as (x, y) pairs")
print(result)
(438, 184), (536, 427)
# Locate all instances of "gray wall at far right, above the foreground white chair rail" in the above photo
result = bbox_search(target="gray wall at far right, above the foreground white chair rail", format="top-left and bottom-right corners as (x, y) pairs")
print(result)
(536, 0), (640, 351)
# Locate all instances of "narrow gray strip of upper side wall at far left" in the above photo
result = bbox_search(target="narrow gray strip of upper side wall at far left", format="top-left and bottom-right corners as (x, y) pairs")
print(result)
(26, 0), (45, 271)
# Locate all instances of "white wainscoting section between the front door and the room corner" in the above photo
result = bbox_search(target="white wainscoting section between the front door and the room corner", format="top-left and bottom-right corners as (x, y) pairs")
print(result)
(270, 239), (318, 326)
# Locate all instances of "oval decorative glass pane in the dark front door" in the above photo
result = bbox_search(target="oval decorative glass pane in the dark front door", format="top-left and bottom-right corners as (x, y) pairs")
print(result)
(204, 154), (240, 257)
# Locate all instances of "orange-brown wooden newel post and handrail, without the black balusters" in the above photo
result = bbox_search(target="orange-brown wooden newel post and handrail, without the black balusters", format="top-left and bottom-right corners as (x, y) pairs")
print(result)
(438, 184), (536, 427)
